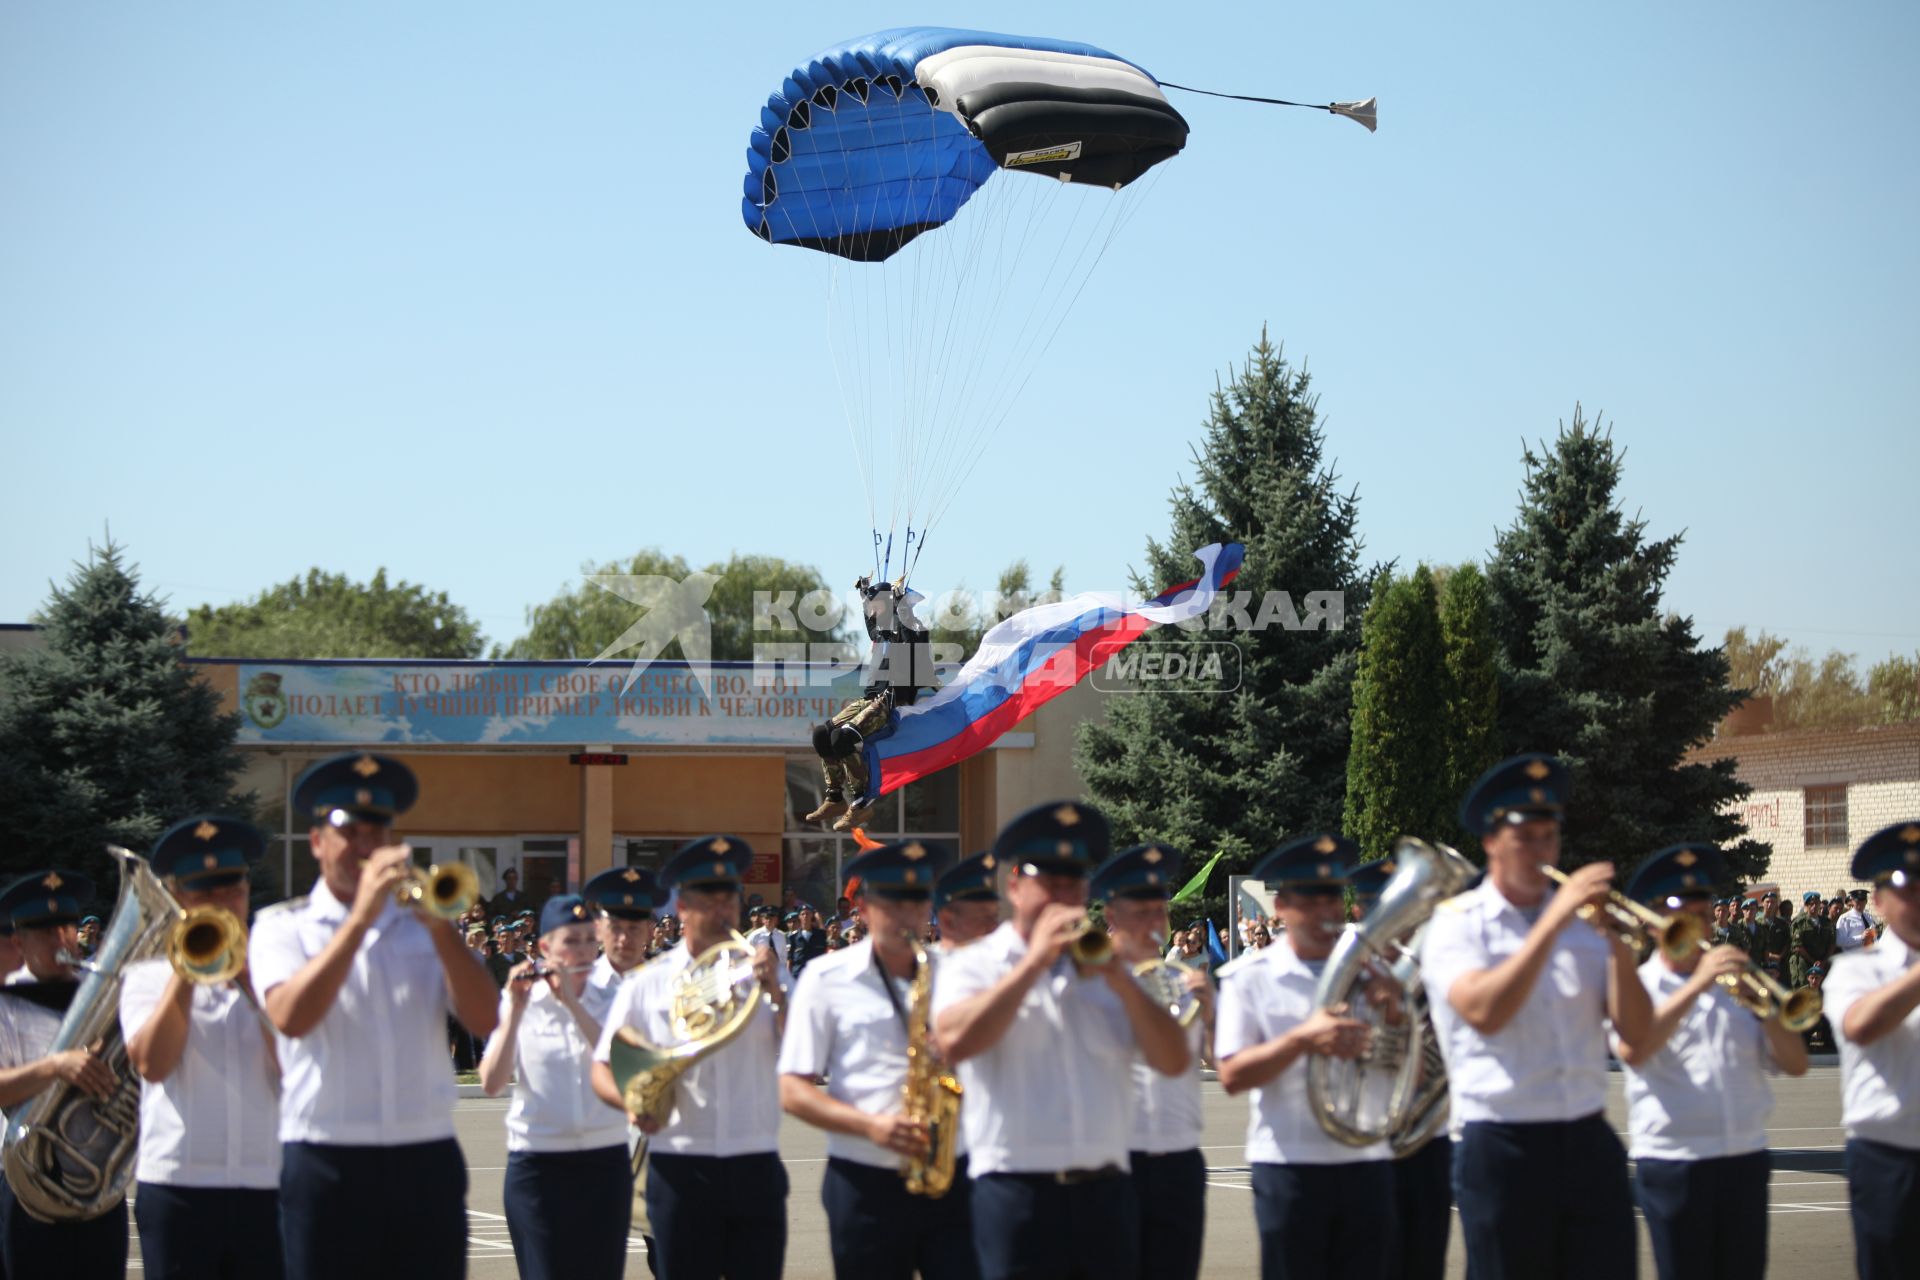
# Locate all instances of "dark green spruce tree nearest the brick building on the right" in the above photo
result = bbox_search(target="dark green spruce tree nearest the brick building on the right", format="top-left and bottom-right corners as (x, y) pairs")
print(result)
(1488, 407), (1772, 879)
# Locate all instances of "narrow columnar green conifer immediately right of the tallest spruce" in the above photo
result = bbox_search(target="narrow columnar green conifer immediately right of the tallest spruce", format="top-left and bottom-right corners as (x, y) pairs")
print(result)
(1346, 564), (1457, 858)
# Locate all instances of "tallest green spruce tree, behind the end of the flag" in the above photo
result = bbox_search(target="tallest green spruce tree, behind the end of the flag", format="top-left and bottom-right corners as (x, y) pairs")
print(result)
(1075, 334), (1373, 919)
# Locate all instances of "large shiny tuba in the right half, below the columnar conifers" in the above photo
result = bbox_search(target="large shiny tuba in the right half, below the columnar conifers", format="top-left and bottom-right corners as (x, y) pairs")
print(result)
(1308, 837), (1478, 1155)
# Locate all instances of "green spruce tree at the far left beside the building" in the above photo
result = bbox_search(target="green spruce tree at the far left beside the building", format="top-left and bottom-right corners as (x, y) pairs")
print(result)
(0, 541), (253, 896)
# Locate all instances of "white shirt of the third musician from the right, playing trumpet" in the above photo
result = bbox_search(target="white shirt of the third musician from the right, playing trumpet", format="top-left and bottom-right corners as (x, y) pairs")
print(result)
(1421, 879), (1611, 1128)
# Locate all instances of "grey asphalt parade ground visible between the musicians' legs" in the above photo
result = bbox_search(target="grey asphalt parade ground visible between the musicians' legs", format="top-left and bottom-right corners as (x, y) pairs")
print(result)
(129, 1067), (1853, 1280)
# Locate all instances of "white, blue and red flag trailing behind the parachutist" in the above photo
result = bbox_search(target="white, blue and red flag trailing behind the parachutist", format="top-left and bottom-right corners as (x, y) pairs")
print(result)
(866, 543), (1246, 796)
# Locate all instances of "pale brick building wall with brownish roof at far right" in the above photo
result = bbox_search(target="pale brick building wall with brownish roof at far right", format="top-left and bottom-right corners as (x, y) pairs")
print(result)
(1688, 722), (1920, 900)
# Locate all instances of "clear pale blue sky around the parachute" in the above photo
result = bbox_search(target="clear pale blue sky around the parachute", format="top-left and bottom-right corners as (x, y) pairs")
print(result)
(0, 0), (1920, 656)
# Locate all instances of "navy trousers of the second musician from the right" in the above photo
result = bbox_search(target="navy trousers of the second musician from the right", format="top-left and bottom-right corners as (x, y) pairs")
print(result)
(1634, 1151), (1772, 1280)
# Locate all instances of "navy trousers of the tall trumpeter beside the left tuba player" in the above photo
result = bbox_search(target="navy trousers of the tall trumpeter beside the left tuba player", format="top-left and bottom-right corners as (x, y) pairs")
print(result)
(280, 1138), (467, 1280)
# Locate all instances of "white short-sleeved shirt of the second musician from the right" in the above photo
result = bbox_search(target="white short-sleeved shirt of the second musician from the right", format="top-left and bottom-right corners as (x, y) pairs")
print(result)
(1620, 959), (1774, 1159)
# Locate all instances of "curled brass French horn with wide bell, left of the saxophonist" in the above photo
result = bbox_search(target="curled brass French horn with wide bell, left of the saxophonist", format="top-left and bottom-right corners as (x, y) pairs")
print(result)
(607, 933), (766, 1125)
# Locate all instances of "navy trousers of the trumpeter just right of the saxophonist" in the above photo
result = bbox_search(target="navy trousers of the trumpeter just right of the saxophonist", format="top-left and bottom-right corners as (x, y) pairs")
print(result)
(973, 1173), (1140, 1280)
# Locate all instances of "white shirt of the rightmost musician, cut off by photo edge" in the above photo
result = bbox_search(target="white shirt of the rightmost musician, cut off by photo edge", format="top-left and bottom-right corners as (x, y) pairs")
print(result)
(1820, 929), (1920, 1151)
